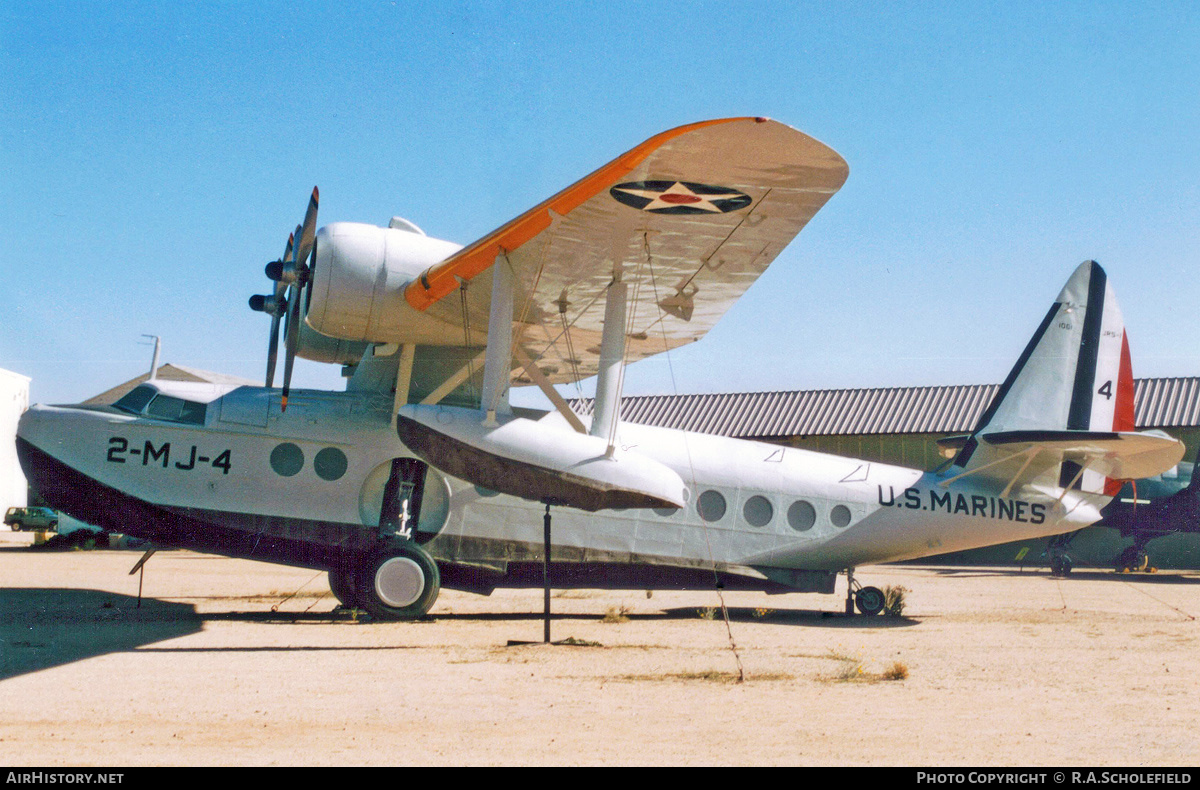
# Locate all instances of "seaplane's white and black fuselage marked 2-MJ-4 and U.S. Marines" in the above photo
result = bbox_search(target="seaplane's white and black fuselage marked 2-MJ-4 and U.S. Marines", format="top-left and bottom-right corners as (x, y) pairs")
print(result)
(18, 383), (1098, 592)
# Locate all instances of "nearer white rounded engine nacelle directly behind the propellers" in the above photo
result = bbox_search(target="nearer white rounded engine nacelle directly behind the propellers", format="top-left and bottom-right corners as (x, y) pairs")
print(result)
(301, 222), (462, 343)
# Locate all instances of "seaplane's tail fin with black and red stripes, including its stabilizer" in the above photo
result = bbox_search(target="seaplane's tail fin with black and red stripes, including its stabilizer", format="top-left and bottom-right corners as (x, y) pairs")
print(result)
(954, 261), (1182, 496)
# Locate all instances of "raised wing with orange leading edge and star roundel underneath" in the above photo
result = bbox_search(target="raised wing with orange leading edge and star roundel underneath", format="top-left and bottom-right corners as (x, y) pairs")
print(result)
(404, 118), (848, 383)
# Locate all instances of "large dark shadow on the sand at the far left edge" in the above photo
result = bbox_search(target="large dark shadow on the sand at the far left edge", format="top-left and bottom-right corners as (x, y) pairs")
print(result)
(0, 587), (203, 681)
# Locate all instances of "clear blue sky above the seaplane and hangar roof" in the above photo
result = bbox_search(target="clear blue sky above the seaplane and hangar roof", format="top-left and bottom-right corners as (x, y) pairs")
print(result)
(0, 1), (1200, 402)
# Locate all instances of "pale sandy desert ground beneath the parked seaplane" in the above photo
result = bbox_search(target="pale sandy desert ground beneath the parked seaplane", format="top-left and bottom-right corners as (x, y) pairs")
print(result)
(0, 533), (1200, 767)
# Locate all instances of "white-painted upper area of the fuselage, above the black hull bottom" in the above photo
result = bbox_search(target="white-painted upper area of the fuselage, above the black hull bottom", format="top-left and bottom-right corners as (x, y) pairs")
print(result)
(19, 388), (1099, 578)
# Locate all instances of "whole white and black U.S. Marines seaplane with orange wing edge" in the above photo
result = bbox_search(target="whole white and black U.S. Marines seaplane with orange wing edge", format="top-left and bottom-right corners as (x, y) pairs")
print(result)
(17, 118), (1183, 620)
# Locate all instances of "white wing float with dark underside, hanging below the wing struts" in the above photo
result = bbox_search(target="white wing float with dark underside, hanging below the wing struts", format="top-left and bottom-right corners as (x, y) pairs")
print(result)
(396, 405), (685, 511)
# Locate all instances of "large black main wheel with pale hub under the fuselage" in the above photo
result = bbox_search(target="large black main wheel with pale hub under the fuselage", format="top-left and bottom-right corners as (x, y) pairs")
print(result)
(355, 541), (442, 620)
